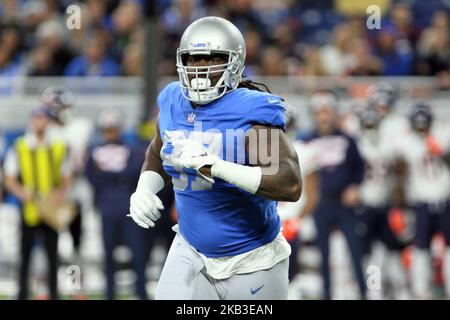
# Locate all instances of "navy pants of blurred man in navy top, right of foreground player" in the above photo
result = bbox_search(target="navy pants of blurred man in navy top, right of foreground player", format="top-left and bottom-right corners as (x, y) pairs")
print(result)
(314, 200), (367, 299)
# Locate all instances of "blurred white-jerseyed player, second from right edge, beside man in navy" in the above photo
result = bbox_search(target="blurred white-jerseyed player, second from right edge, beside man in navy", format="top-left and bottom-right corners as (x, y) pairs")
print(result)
(358, 106), (408, 299)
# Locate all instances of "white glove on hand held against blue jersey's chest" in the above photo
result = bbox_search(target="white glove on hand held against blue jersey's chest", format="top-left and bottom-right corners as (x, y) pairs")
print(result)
(172, 139), (220, 183)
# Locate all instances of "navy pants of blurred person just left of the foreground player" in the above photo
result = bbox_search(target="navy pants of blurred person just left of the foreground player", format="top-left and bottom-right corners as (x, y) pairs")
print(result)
(102, 212), (148, 299)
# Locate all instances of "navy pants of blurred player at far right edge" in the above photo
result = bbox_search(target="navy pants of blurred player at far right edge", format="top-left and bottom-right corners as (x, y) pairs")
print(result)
(414, 201), (450, 249)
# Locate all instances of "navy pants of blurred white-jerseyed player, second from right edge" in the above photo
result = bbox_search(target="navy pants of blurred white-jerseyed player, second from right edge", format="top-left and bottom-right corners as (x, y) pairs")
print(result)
(359, 207), (404, 254)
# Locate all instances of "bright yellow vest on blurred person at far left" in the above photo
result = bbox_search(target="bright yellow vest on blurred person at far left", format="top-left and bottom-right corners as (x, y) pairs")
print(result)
(16, 137), (66, 227)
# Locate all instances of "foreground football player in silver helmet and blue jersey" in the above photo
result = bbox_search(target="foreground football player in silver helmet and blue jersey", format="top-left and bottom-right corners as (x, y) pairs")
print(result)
(130, 17), (301, 299)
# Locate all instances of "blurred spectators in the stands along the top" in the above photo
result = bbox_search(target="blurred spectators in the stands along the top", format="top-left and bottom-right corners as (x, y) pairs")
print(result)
(0, 0), (450, 82)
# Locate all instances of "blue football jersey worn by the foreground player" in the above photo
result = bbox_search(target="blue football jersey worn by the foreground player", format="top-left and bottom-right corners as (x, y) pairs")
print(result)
(158, 82), (285, 257)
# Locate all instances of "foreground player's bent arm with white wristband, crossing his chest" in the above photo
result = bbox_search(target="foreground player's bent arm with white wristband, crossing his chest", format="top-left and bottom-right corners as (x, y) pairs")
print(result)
(199, 125), (302, 202)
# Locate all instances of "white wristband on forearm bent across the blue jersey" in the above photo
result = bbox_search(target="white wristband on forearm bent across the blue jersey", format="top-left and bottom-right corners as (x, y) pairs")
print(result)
(211, 160), (262, 194)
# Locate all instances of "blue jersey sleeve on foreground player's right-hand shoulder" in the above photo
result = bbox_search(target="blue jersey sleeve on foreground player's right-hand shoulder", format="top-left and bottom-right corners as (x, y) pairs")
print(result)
(248, 92), (286, 130)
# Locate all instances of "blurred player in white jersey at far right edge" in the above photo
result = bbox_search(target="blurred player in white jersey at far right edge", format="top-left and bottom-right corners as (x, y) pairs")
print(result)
(397, 102), (450, 299)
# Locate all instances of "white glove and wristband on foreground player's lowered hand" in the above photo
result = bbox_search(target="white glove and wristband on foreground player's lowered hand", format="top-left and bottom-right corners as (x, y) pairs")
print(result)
(127, 171), (164, 229)
